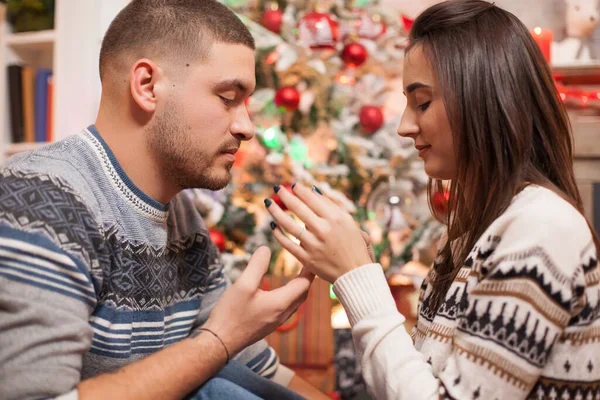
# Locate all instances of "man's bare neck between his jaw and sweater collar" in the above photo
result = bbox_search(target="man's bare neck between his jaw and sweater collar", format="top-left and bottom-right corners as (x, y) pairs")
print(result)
(95, 107), (179, 204)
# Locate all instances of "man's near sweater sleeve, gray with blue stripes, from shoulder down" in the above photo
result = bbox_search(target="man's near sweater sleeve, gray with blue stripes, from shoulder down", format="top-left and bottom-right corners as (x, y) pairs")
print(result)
(0, 171), (99, 400)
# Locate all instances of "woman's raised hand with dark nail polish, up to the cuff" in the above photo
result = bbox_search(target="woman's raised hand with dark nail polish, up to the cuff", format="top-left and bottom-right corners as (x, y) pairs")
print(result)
(265, 184), (373, 283)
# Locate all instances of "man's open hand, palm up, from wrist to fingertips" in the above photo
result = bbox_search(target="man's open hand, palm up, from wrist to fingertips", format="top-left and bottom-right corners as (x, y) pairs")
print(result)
(204, 247), (314, 357)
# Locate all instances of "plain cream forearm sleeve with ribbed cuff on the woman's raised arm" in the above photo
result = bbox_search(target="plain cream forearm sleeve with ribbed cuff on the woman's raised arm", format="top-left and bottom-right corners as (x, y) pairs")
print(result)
(333, 264), (439, 400)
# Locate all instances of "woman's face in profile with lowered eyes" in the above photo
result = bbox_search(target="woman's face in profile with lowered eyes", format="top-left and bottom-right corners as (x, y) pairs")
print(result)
(398, 46), (456, 180)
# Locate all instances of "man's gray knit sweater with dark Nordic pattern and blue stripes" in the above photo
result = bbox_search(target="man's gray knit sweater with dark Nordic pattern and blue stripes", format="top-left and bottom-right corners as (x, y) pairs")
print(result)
(0, 126), (279, 400)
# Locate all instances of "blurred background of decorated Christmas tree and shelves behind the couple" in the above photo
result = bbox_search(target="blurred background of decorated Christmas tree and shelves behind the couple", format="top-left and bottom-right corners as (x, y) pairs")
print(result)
(0, 0), (600, 399)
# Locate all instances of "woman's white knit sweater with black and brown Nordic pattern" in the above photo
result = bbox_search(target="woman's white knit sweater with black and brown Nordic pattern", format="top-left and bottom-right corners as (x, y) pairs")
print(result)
(334, 186), (600, 400)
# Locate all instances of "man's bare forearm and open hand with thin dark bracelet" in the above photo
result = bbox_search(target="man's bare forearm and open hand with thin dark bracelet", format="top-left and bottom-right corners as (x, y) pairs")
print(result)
(78, 248), (314, 400)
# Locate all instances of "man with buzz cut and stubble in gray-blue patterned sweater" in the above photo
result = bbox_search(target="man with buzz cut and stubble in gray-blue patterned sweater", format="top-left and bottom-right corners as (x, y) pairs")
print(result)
(0, 0), (323, 399)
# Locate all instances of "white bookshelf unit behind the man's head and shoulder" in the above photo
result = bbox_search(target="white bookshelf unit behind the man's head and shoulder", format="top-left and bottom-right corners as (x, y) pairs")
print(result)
(0, 0), (129, 164)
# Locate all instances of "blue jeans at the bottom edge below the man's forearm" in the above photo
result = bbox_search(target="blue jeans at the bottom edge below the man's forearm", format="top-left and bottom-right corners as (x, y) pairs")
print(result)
(188, 360), (304, 400)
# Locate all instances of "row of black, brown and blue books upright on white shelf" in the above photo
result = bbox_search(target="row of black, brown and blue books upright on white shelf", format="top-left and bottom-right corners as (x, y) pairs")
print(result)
(8, 64), (54, 143)
